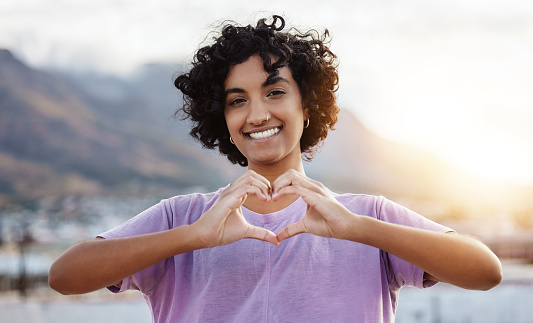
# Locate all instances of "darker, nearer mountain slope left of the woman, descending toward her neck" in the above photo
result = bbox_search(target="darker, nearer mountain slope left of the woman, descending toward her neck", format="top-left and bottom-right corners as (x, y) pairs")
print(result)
(0, 50), (239, 208)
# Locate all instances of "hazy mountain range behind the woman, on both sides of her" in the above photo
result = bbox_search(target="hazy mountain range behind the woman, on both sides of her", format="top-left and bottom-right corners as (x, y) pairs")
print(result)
(0, 50), (531, 219)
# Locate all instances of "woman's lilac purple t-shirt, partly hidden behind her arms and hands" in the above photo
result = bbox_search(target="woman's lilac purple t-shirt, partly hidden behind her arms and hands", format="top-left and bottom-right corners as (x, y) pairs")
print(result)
(101, 189), (450, 322)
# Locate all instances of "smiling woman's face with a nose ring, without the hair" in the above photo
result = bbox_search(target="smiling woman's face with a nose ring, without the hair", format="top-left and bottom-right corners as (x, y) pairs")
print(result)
(224, 55), (307, 168)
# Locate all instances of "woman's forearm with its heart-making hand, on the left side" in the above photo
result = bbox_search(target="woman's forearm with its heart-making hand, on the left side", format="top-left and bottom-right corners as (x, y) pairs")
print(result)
(48, 171), (279, 294)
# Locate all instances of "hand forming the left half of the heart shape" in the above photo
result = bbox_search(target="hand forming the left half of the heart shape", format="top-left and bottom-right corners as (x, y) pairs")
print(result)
(192, 170), (279, 248)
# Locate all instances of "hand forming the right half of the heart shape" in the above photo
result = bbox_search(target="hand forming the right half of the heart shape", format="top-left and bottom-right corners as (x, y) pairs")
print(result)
(272, 170), (358, 242)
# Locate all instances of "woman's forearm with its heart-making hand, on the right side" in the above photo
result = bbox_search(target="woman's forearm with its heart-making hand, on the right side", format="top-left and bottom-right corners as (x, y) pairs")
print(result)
(272, 171), (502, 290)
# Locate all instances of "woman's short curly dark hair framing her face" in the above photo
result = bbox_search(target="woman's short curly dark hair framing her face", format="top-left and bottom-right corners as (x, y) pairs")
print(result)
(174, 15), (339, 166)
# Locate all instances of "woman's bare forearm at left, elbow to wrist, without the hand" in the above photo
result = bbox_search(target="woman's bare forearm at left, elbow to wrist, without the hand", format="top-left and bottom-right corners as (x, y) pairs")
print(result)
(48, 226), (201, 295)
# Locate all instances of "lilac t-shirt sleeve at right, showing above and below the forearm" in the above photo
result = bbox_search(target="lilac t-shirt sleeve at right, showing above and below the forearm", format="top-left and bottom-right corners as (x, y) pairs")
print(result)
(377, 197), (453, 288)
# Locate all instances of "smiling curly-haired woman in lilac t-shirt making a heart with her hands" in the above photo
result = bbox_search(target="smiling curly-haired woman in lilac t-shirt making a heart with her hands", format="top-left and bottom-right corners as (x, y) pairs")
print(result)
(49, 16), (502, 322)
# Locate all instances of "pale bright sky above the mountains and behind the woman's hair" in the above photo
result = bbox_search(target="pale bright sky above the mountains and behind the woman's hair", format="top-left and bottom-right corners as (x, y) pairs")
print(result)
(0, 0), (533, 185)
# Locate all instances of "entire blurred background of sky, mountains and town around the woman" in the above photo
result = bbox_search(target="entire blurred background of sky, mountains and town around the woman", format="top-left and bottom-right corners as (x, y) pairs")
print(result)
(0, 0), (533, 323)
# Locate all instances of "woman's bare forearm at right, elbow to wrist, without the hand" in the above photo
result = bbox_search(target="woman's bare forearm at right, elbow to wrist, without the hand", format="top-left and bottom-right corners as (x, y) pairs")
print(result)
(347, 216), (502, 290)
